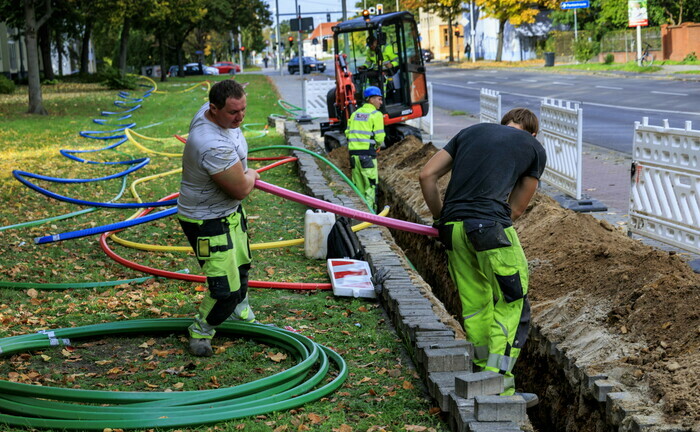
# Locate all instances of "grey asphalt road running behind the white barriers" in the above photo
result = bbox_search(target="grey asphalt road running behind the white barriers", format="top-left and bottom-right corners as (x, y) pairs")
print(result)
(428, 66), (700, 154)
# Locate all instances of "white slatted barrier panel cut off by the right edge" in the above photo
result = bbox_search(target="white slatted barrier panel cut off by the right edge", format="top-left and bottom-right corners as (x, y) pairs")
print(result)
(629, 117), (700, 253)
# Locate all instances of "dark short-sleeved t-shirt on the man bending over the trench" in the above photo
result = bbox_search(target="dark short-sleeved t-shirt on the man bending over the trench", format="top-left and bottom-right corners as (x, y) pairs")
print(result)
(440, 123), (547, 226)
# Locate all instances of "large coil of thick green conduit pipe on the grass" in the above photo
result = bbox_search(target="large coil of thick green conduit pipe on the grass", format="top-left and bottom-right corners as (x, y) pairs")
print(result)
(0, 318), (348, 430)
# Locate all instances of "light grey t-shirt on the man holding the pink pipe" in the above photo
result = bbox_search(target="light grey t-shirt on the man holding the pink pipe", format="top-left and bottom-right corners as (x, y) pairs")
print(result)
(177, 102), (248, 220)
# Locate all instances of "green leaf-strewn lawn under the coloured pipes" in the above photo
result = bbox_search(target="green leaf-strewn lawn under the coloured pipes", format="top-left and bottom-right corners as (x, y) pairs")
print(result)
(0, 75), (449, 432)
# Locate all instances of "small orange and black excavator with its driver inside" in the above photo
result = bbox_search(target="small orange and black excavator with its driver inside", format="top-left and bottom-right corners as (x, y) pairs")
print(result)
(321, 12), (428, 151)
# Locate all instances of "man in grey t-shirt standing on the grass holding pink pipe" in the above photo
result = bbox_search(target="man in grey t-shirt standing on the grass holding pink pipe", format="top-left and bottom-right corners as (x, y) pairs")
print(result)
(177, 80), (260, 357)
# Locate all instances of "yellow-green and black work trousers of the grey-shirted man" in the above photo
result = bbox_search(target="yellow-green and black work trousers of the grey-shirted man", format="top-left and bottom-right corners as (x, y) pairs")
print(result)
(178, 207), (255, 339)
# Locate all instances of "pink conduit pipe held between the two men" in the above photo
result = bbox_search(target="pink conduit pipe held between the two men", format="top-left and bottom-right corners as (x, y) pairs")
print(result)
(255, 180), (438, 237)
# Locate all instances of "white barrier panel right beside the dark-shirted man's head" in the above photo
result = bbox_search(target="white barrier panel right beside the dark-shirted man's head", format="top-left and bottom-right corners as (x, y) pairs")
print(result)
(540, 98), (583, 200)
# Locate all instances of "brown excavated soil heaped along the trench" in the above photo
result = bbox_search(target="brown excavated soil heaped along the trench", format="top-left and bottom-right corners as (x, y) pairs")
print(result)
(330, 137), (700, 430)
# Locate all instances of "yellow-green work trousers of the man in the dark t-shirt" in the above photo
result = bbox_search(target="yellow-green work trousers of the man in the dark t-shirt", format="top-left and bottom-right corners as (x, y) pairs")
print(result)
(441, 221), (530, 395)
